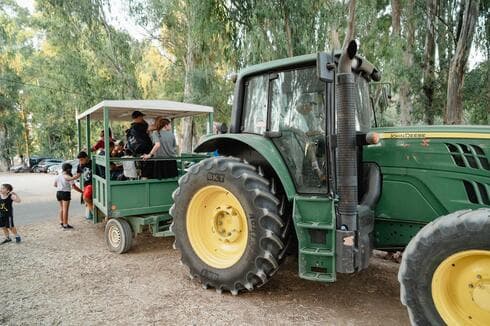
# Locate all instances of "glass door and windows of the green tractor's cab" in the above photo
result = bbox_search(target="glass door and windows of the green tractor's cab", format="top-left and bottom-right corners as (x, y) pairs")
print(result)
(232, 55), (378, 193)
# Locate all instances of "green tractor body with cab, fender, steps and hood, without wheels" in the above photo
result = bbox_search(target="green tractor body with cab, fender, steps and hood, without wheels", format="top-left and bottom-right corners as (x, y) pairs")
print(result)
(196, 54), (490, 282)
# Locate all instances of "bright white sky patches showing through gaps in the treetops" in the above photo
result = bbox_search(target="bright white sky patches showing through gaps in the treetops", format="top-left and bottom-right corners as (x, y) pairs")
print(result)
(12, 0), (485, 70)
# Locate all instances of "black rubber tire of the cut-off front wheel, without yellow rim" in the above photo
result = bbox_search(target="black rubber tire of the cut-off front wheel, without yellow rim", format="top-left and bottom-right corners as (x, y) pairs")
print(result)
(398, 208), (490, 325)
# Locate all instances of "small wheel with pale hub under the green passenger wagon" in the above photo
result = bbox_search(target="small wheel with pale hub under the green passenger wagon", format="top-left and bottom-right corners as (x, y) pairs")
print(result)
(104, 218), (133, 254)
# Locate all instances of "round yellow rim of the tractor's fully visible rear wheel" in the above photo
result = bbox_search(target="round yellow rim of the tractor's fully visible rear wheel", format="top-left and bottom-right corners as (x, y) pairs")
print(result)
(186, 186), (248, 269)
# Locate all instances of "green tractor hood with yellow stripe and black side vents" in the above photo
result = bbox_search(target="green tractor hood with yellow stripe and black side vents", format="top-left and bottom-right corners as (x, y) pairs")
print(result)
(363, 126), (490, 249)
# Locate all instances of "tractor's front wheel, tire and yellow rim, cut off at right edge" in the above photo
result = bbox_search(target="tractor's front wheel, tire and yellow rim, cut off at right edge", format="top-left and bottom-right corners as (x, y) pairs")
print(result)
(398, 209), (490, 325)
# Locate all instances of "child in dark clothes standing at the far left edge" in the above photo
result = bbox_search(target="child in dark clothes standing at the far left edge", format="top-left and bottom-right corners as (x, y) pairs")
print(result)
(0, 183), (20, 244)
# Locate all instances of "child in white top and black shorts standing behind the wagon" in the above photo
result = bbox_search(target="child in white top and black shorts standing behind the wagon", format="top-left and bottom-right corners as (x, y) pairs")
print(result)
(54, 163), (82, 230)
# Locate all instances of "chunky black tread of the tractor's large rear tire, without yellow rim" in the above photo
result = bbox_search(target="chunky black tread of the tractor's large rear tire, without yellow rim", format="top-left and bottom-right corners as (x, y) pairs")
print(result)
(170, 157), (286, 295)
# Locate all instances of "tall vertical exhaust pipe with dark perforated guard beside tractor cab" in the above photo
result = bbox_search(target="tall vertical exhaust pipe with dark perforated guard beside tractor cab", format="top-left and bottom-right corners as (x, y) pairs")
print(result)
(336, 41), (358, 273)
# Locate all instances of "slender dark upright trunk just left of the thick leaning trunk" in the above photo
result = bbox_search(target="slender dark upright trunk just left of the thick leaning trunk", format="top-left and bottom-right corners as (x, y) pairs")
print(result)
(422, 0), (438, 125)
